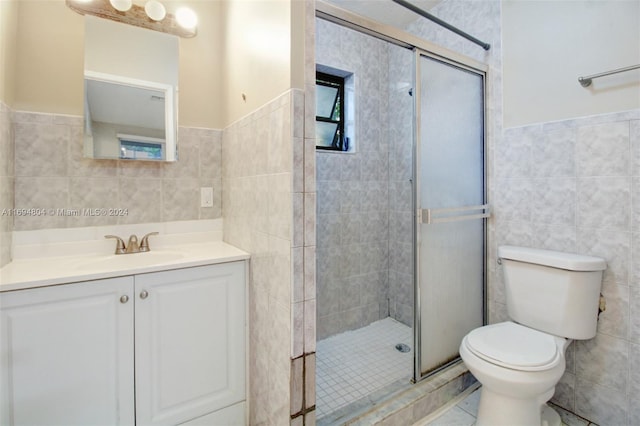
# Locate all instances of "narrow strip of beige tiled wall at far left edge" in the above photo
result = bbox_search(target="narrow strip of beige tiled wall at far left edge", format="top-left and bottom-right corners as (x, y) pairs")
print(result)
(0, 102), (14, 268)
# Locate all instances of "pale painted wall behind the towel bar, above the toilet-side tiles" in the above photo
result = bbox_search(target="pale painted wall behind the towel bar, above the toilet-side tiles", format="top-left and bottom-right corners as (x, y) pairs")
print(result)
(502, 0), (640, 127)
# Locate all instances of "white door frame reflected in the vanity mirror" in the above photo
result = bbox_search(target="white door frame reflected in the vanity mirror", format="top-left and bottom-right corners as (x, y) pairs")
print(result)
(84, 70), (178, 162)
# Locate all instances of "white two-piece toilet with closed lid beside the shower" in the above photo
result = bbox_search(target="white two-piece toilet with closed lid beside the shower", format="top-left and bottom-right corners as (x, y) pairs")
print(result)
(460, 246), (606, 426)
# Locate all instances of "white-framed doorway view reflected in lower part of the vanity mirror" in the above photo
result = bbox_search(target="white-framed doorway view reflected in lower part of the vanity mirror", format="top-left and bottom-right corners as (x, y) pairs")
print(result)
(84, 72), (175, 161)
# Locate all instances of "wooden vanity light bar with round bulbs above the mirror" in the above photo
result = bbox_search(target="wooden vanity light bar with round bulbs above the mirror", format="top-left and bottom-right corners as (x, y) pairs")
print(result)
(66, 0), (198, 38)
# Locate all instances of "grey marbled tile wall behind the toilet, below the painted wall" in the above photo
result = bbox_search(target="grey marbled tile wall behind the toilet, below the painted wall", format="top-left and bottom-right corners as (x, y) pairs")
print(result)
(490, 110), (640, 425)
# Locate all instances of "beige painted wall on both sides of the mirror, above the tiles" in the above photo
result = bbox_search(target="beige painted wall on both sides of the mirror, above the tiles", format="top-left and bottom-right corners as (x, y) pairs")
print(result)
(10, 0), (224, 128)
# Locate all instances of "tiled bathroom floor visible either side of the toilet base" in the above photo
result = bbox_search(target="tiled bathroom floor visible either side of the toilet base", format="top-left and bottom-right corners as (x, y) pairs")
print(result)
(414, 389), (597, 426)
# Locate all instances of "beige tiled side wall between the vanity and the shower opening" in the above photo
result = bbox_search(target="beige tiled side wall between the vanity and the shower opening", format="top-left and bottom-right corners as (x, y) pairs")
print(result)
(222, 93), (293, 425)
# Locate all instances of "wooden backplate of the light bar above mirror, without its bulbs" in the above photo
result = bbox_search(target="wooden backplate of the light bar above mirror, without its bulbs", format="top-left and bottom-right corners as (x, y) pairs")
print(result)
(66, 0), (197, 38)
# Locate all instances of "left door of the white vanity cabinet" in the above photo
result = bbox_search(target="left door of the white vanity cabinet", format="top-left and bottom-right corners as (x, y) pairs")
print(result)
(0, 277), (134, 426)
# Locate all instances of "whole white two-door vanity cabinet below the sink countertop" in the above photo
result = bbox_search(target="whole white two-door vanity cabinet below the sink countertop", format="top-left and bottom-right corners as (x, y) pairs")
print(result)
(0, 261), (246, 425)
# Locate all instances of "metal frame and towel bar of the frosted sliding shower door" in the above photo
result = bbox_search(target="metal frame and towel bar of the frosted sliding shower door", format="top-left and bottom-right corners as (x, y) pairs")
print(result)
(413, 47), (490, 383)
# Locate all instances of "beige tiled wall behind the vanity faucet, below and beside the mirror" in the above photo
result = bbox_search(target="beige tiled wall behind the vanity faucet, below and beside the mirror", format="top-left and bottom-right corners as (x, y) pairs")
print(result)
(6, 111), (222, 231)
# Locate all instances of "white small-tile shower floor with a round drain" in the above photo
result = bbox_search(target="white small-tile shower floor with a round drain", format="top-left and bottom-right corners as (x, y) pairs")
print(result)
(316, 318), (413, 419)
